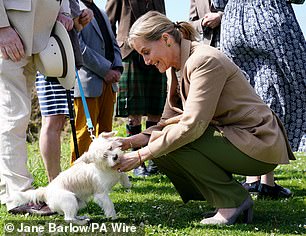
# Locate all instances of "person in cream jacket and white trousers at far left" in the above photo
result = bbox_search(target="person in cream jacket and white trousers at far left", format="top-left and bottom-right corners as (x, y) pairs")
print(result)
(0, 0), (73, 215)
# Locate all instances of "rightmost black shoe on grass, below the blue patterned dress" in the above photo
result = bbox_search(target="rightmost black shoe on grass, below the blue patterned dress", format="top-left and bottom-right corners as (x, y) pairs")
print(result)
(258, 184), (292, 199)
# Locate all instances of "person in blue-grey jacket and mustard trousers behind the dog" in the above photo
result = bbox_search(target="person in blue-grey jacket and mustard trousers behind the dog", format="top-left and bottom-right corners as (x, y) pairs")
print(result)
(71, 0), (123, 163)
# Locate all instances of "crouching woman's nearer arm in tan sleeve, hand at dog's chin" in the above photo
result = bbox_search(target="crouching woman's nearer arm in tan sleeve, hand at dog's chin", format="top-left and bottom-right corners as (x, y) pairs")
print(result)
(115, 53), (227, 171)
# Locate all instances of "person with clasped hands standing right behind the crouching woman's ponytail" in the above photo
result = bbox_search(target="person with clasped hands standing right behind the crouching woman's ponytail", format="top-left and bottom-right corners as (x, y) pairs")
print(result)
(189, 0), (223, 48)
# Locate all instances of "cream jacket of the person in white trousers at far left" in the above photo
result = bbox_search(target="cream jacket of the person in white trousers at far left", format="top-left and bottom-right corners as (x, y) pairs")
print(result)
(0, 0), (69, 56)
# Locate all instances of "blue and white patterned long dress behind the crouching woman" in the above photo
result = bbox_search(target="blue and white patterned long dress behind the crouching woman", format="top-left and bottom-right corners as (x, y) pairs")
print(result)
(216, 0), (306, 151)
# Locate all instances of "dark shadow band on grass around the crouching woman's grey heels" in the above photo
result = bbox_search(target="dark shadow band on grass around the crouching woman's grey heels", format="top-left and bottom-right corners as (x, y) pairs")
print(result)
(80, 195), (306, 235)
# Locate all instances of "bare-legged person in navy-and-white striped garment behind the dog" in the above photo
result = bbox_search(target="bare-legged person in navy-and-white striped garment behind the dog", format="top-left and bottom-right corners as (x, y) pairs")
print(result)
(35, 0), (93, 182)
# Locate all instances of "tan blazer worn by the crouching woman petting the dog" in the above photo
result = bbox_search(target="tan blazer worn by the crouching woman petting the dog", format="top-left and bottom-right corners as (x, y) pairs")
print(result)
(143, 39), (294, 164)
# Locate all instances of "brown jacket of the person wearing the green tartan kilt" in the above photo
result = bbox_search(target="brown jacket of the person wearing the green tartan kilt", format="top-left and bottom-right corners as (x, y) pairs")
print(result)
(105, 0), (166, 59)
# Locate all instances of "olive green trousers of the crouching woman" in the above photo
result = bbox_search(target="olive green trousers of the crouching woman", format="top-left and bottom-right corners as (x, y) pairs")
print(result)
(154, 126), (277, 208)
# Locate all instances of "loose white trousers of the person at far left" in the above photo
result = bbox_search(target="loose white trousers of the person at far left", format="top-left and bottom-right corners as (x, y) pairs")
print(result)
(0, 54), (36, 210)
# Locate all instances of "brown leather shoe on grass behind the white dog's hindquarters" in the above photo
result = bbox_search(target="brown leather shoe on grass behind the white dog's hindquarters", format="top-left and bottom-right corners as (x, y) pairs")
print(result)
(9, 203), (56, 216)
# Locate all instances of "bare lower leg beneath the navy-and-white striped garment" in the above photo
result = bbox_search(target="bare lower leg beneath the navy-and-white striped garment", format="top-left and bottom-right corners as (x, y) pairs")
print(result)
(39, 114), (66, 182)
